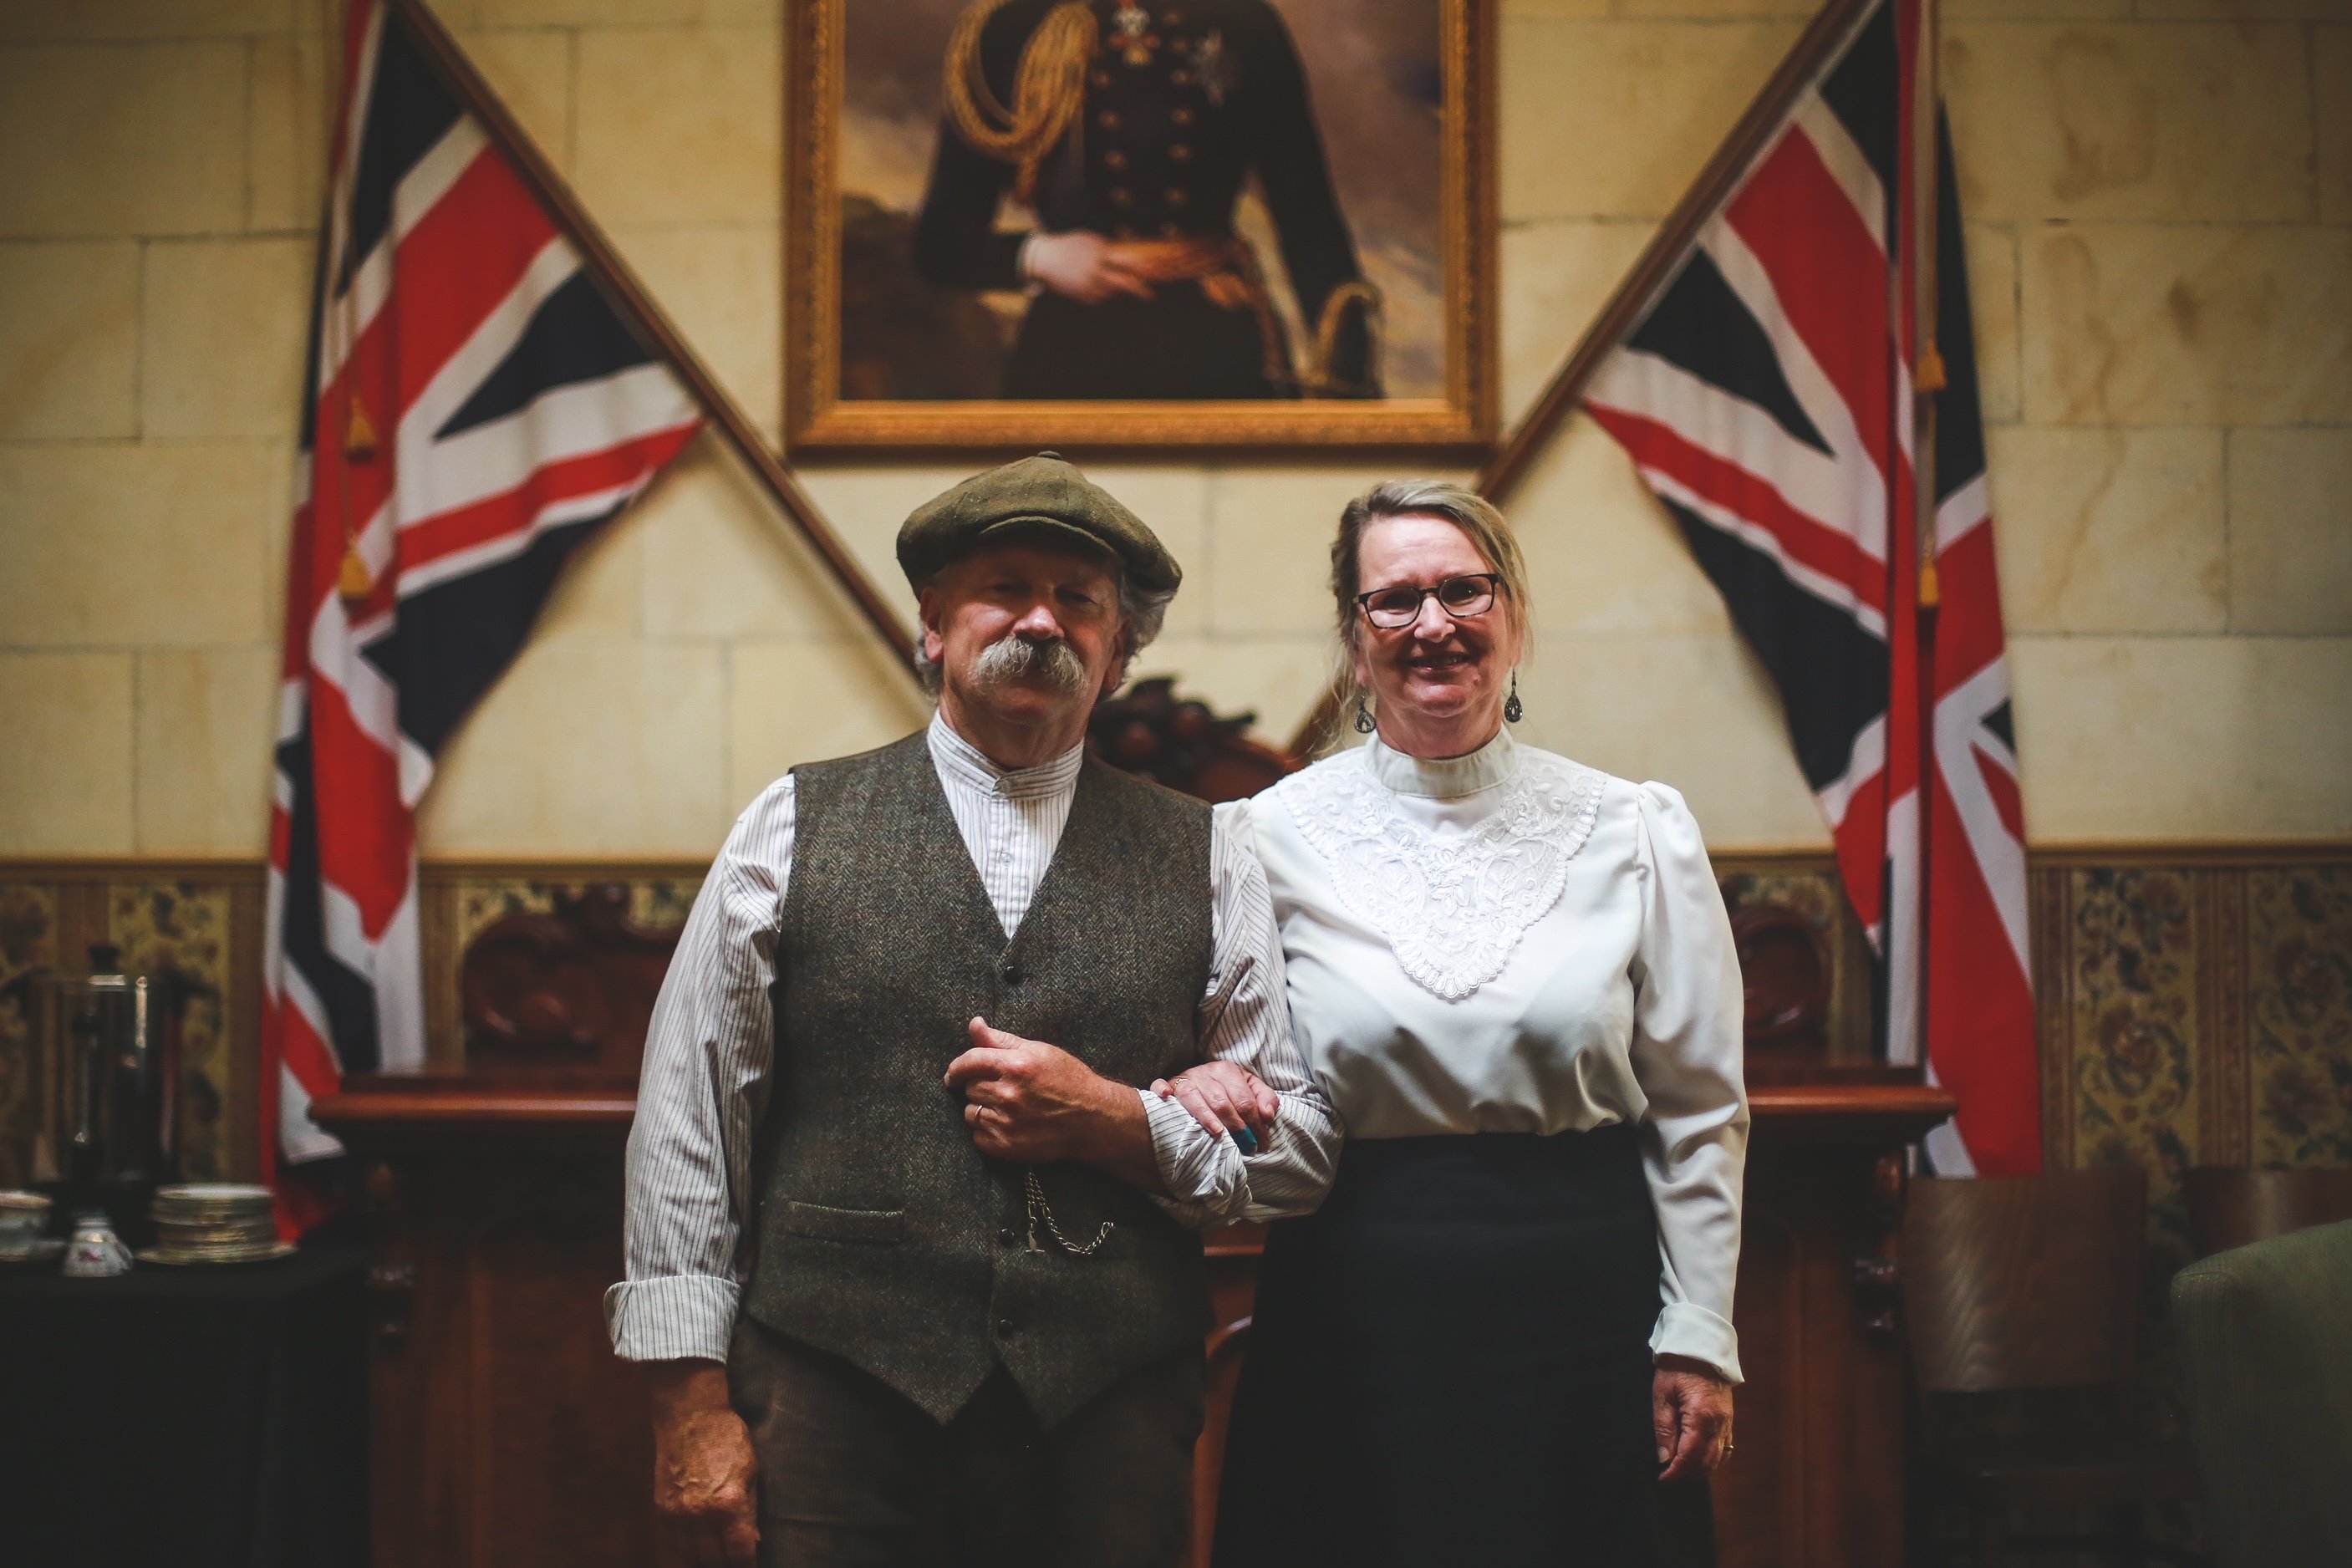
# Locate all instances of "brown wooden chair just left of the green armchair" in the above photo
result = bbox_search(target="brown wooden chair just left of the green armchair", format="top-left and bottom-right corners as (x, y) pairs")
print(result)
(1903, 1166), (2204, 1568)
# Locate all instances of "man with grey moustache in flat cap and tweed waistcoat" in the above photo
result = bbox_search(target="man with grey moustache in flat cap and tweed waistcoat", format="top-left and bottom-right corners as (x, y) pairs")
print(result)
(607, 454), (1336, 1568)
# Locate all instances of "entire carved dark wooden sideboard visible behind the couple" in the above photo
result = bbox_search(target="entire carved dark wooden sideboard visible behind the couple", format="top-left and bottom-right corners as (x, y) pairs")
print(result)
(313, 700), (1952, 1568)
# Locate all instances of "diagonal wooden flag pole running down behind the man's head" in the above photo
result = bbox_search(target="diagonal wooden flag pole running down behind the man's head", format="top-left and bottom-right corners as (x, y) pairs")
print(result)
(388, 0), (915, 680)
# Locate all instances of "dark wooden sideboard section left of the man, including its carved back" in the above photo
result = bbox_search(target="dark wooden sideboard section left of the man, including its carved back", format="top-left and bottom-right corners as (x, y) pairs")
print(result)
(313, 884), (677, 1568)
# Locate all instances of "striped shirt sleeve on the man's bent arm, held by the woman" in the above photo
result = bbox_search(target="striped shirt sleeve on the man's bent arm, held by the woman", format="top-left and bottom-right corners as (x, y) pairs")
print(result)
(1141, 807), (1341, 1229)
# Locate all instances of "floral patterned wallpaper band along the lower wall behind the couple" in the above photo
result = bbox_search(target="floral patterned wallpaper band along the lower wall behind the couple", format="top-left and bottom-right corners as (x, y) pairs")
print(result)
(0, 848), (2352, 1260)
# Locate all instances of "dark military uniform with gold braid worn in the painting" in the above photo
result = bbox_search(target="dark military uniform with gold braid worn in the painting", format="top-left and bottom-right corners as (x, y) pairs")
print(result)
(915, 0), (1381, 400)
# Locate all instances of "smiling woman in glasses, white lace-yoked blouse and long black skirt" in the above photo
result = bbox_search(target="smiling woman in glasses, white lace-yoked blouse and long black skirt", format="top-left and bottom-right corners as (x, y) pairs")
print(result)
(1171, 480), (1748, 1568)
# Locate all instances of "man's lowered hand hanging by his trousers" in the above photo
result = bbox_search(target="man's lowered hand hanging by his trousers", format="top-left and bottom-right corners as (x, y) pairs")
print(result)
(644, 1361), (760, 1568)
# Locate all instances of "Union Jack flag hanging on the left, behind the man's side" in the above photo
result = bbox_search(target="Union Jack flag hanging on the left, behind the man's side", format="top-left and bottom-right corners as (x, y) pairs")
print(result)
(261, 0), (699, 1229)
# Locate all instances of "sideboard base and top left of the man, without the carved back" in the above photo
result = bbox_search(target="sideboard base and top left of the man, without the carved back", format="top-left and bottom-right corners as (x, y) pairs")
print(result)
(315, 1074), (656, 1568)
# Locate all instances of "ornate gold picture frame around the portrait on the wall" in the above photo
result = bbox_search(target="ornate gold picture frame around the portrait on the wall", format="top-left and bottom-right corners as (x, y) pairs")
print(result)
(783, 0), (1496, 458)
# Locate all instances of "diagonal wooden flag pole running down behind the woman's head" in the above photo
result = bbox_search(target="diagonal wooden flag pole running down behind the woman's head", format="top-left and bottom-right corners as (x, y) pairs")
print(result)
(1289, 0), (1877, 761)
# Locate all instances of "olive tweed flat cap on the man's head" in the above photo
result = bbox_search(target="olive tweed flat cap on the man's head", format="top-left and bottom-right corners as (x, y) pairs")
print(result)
(899, 451), (1183, 593)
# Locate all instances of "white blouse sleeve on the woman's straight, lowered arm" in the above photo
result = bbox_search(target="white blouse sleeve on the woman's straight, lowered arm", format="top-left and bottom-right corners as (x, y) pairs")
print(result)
(1632, 783), (1748, 1382)
